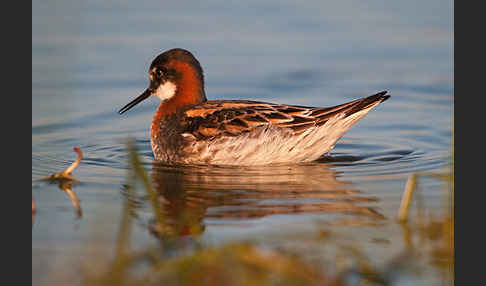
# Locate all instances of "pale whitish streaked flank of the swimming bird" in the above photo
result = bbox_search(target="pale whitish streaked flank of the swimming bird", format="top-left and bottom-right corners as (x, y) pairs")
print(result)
(177, 102), (379, 165)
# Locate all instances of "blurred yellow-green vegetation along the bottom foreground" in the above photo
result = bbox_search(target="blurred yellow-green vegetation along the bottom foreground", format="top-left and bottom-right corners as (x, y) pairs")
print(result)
(82, 141), (454, 286)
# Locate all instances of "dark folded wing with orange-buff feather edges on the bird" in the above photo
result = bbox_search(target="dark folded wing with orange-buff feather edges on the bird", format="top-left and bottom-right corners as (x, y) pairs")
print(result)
(183, 91), (389, 139)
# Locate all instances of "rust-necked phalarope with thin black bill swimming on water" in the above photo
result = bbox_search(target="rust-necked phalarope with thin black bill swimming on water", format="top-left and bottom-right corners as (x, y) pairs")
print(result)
(118, 48), (390, 166)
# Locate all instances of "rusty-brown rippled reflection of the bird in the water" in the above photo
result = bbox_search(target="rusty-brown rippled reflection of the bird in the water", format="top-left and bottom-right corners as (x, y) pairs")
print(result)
(146, 162), (384, 235)
